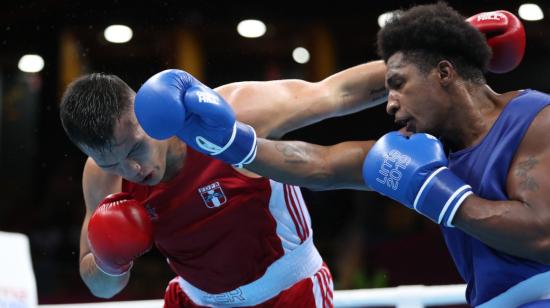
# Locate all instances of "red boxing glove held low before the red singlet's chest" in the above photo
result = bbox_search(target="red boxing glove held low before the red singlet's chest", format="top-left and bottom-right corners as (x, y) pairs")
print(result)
(88, 193), (153, 276)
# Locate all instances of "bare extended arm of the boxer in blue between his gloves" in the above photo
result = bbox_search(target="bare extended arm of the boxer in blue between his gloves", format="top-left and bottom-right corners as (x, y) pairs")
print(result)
(246, 138), (370, 190)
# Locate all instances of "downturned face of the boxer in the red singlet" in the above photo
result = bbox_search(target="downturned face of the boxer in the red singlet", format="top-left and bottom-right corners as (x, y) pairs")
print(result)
(80, 111), (167, 185)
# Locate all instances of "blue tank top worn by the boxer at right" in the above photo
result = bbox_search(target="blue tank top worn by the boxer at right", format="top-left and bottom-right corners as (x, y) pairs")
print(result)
(442, 90), (550, 306)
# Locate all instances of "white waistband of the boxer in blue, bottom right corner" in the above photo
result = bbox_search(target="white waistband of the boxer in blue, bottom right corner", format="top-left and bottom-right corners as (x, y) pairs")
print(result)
(477, 271), (550, 308)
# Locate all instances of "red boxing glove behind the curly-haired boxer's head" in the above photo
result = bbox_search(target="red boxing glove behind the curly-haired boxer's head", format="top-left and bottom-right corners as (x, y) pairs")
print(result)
(466, 11), (525, 74)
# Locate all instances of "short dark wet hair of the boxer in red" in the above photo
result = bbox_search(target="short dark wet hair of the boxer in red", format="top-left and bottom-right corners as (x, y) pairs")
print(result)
(59, 73), (135, 151)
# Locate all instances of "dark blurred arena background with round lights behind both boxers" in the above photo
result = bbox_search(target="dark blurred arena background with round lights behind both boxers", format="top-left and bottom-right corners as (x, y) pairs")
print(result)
(0, 0), (550, 304)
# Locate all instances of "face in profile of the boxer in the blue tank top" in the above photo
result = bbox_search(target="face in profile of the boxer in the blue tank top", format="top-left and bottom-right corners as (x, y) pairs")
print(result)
(386, 53), (454, 136)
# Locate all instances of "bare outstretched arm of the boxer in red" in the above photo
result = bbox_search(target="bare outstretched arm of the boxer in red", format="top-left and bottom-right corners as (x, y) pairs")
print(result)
(216, 61), (386, 138)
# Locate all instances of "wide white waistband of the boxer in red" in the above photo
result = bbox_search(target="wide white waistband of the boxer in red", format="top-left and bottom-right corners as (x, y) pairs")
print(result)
(178, 238), (323, 307)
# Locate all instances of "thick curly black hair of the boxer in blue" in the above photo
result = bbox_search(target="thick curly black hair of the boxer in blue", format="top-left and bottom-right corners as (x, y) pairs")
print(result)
(377, 2), (491, 83)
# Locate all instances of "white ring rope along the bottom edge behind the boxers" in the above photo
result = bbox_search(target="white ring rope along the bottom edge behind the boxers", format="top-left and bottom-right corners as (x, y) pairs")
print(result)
(38, 284), (466, 308)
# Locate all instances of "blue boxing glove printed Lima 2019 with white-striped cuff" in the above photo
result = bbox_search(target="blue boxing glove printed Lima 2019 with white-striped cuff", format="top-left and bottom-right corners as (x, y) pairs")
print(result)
(363, 132), (472, 227)
